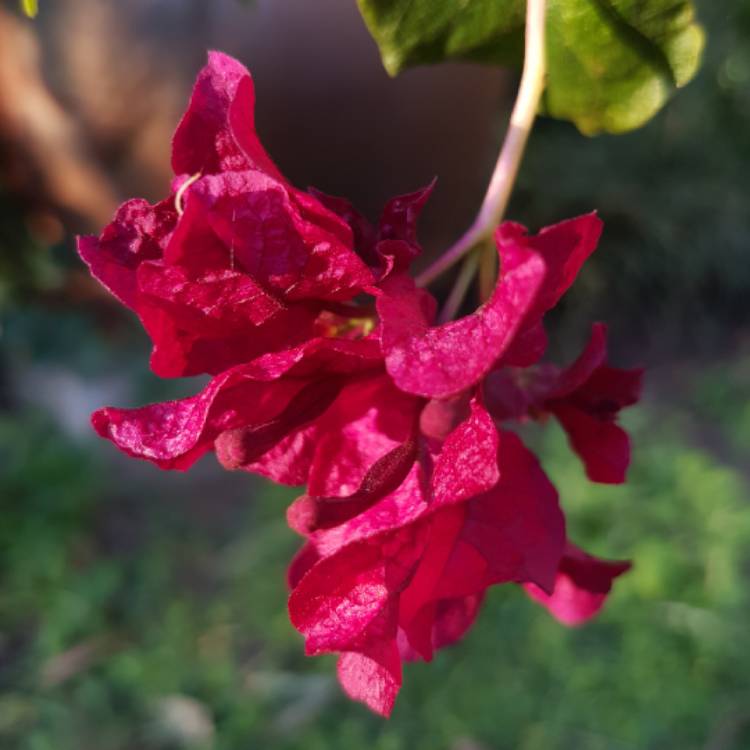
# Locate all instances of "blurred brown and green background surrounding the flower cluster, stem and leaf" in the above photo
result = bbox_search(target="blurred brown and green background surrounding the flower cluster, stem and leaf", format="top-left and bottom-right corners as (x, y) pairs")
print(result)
(0, 0), (750, 750)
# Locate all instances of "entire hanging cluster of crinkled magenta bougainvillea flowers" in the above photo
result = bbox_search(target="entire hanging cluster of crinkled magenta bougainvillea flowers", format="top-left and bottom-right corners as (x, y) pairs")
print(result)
(79, 53), (641, 715)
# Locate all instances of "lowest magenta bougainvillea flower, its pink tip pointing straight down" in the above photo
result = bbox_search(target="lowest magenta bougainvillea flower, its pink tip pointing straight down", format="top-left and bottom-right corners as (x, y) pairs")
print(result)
(289, 428), (565, 715)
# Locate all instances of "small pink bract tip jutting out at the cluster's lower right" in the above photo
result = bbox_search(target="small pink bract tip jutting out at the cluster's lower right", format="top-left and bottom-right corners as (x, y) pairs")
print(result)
(524, 543), (631, 626)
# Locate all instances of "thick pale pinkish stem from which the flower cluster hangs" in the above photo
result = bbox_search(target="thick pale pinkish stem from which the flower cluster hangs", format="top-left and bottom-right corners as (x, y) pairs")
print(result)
(417, 0), (547, 286)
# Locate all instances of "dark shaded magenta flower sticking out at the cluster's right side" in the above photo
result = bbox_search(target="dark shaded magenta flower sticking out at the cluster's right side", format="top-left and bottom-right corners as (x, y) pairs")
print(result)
(485, 323), (643, 484)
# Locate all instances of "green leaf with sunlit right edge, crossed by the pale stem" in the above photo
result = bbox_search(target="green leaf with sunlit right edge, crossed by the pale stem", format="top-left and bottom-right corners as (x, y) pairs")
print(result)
(358, 0), (704, 135)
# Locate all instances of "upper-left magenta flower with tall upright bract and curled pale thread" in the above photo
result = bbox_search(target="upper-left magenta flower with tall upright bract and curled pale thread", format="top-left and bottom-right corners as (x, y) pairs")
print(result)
(79, 53), (374, 376)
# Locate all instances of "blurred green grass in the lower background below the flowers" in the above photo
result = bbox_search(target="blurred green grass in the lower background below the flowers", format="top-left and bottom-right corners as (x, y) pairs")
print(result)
(0, 352), (750, 750)
